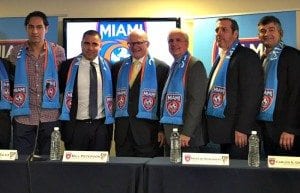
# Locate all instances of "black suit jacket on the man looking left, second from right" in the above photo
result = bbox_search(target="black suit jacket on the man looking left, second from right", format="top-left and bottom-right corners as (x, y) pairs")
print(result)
(207, 45), (264, 144)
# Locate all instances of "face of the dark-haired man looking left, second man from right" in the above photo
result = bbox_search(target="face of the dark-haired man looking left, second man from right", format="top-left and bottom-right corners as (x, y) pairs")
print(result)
(215, 20), (238, 50)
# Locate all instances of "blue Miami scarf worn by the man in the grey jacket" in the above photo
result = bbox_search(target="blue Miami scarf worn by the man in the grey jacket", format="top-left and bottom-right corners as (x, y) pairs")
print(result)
(160, 52), (191, 125)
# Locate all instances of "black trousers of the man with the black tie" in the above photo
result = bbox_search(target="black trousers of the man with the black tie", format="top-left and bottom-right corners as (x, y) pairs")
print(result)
(62, 118), (112, 151)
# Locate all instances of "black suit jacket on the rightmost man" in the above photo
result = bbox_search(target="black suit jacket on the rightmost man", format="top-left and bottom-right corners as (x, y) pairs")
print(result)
(264, 46), (300, 137)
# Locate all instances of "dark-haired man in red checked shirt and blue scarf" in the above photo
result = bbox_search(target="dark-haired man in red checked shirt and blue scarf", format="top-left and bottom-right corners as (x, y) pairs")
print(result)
(10, 11), (65, 154)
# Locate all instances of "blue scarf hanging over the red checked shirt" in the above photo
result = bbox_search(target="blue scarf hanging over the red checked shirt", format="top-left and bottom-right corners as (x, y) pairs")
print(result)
(11, 42), (60, 116)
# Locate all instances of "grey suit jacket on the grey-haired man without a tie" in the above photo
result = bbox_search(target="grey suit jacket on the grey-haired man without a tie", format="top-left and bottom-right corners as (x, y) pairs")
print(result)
(164, 57), (208, 147)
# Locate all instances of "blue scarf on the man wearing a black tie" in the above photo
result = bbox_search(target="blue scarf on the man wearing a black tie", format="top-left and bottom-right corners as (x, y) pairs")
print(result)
(59, 55), (114, 124)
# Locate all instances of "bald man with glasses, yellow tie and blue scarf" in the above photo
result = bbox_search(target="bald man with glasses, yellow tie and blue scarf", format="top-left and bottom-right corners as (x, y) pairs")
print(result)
(113, 30), (169, 157)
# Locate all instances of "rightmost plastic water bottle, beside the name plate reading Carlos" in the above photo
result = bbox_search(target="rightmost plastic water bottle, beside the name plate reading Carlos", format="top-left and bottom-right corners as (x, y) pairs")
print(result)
(248, 131), (260, 167)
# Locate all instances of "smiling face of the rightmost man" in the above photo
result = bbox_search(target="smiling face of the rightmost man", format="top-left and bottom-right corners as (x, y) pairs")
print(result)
(258, 22), (282, 49)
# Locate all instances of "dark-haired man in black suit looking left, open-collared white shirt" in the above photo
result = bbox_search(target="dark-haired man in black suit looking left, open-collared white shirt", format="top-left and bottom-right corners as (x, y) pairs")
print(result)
(206, 18), (263, 159)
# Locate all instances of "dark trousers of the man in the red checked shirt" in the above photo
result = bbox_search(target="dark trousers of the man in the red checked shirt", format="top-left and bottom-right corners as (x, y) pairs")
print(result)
(13, 119), (60, 155)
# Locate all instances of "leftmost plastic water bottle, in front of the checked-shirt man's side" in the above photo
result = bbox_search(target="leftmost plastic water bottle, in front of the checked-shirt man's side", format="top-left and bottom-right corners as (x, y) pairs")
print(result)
(50, 127), (61, 160)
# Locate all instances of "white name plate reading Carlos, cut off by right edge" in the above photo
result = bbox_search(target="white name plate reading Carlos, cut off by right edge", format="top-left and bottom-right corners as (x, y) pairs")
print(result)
(268, 155), (300, 169)
